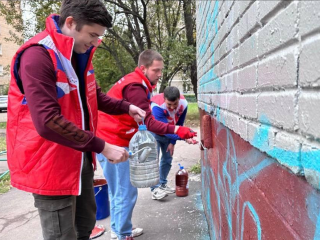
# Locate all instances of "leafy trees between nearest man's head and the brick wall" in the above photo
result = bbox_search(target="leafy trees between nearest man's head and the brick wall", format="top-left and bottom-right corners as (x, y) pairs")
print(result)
(105, 0), (197, 92)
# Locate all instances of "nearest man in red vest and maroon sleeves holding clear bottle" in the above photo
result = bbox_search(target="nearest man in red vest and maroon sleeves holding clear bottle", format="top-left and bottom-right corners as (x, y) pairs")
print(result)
(7, 0), (145, 240)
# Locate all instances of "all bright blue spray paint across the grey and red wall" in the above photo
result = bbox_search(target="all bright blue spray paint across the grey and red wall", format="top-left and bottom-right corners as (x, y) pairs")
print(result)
(198, 1), (320, 240)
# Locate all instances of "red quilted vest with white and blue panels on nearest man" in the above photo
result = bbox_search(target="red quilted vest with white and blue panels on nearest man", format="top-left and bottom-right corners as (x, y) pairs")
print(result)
(7, 15), (98, 195)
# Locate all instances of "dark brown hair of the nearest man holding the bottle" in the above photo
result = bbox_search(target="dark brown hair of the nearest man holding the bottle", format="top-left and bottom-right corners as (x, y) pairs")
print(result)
(59, 0), (112, 31)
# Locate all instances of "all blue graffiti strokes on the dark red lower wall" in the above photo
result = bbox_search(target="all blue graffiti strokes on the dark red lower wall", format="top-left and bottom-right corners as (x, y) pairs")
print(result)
(202, 119), (320, 240)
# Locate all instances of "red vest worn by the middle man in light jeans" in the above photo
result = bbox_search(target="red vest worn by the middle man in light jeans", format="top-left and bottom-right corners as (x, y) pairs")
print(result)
(97, 68), (152, 147)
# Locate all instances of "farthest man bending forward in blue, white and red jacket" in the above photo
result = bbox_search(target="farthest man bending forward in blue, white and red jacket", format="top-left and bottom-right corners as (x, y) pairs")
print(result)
(151, 86), (197, 200)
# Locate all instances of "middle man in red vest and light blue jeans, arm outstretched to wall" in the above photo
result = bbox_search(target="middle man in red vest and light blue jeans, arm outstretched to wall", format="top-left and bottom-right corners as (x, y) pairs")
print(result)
(97, 50), (196, 239)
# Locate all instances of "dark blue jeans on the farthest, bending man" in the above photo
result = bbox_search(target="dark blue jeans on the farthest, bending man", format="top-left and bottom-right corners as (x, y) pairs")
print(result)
(151, 134), (172, 191)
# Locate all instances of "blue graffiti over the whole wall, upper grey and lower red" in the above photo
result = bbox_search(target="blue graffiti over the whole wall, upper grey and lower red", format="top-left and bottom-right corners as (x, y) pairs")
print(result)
(198, 1), (320, 240)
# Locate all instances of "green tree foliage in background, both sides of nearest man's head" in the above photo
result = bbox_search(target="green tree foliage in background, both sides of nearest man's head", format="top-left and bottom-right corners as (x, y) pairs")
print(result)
(0, 0), (197, 93)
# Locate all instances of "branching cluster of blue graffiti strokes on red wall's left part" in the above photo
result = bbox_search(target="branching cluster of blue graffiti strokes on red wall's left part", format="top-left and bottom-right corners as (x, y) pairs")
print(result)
(202, 124), (274, 239)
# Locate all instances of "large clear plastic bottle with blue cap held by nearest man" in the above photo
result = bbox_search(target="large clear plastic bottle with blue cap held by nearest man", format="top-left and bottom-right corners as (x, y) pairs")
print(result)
(129, 124), (160, 188)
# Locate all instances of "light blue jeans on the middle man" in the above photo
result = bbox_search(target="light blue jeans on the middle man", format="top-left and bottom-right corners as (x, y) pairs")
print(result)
(97, 151), (138, 239)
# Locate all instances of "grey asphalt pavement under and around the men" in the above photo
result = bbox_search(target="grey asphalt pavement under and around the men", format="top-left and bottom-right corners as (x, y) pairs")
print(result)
(0, 126), (210, 240)
